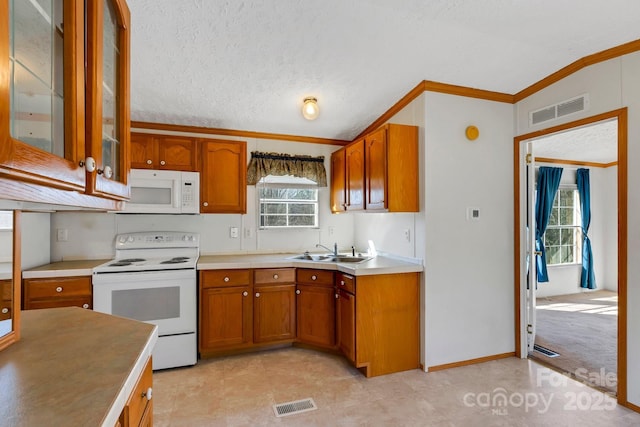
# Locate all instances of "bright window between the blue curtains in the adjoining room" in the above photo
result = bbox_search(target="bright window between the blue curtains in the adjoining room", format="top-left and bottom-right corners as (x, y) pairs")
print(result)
(543, 187), (582, 265)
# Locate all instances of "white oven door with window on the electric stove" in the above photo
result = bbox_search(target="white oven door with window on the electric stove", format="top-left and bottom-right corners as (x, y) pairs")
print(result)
(93, 270), (197, 336)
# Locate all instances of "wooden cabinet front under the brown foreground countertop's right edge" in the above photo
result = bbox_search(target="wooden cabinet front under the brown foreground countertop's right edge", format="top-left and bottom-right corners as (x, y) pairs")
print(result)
(117, 358), (153, 427)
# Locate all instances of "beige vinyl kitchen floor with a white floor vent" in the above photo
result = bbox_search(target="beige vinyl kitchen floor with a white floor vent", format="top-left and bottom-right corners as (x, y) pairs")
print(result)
(153, 348), (640, 427)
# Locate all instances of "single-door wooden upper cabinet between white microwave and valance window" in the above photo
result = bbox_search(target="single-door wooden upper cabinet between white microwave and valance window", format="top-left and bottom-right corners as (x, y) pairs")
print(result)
(200, 139), (247, 213)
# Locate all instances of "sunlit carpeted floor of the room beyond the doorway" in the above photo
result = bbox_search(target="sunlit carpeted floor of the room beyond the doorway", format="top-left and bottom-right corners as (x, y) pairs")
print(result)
(532, 291), (618, 393)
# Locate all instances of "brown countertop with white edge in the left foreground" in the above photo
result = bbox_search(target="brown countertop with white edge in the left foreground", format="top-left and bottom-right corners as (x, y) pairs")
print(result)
(0, 307), (158, 427)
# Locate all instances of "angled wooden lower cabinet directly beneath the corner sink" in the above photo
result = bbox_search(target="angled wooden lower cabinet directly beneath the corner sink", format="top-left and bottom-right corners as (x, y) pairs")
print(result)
(296, 268), (336, 349)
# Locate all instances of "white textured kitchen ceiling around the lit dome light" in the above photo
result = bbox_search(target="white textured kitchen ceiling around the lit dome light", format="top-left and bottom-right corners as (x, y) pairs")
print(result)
(128, 0), (640, 140)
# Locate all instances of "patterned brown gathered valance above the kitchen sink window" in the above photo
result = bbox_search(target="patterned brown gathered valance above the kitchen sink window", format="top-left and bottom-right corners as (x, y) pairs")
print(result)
(247, 151), (327, 187)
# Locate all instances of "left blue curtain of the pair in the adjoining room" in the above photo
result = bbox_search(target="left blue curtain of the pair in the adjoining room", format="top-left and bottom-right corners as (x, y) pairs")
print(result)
(535, 166), (562, 282)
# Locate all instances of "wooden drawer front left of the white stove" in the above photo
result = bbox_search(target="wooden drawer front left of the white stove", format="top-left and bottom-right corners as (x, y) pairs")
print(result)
(22, 276), (93, 310)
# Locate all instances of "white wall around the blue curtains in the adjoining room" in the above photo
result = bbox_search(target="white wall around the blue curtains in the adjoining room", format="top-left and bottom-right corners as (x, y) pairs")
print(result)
(537, 163), (618, 297)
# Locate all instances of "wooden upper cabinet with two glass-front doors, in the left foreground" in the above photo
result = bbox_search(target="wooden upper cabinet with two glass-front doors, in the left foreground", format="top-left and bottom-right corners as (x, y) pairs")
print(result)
(0, 0), (130, 200)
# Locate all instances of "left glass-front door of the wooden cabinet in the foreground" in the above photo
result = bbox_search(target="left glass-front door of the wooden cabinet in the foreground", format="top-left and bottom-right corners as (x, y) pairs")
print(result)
(0, 0), (85, 192)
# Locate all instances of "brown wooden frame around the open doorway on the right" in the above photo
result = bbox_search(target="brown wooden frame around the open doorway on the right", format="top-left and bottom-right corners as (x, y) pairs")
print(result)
(513, 107), (628, 406)
